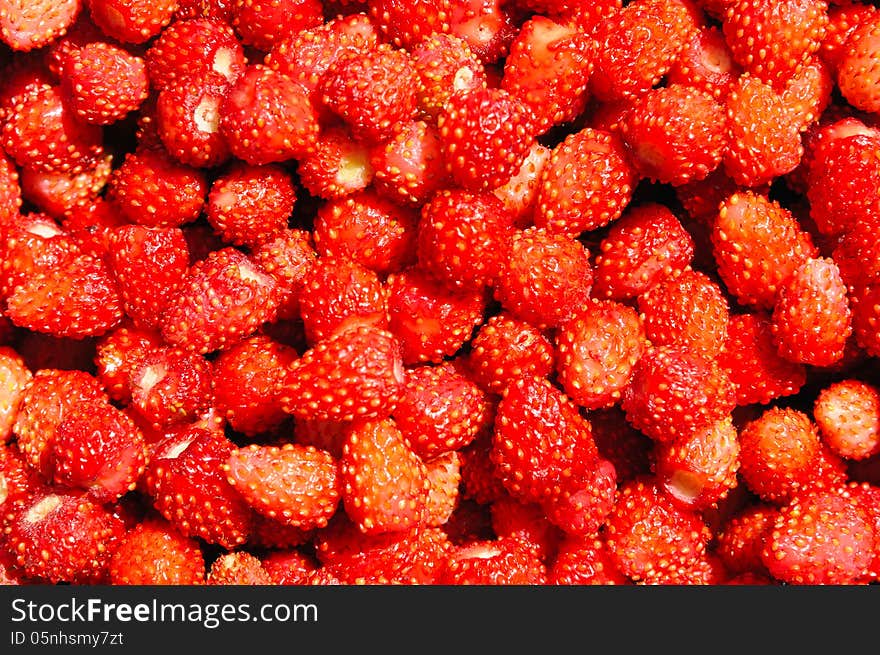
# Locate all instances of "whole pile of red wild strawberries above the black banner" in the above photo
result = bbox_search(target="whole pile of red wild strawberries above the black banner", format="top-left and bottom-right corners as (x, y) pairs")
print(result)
(0, 0), (880, 585)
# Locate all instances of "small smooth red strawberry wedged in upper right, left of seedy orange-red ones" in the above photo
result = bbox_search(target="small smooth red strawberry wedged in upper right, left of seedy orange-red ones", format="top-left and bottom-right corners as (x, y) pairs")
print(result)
(666, 25), (741, 101)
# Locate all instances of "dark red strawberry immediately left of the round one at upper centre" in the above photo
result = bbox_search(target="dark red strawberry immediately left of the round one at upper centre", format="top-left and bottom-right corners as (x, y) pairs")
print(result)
(312, 189), (418, 275)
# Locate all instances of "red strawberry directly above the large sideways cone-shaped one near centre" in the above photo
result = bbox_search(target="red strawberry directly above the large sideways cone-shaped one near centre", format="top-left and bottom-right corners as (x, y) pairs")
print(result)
(299, 256), (388, 345)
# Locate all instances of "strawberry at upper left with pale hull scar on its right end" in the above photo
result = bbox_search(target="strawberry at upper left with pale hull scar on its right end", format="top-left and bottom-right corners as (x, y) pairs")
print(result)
(144, 16), (245, 91)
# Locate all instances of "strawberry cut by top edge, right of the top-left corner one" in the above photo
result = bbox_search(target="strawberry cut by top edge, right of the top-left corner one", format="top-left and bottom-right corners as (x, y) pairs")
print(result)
(88, 0), (178, 43)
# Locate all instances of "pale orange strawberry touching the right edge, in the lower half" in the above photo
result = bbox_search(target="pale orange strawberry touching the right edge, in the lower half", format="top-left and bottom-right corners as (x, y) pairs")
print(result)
(813, 378), (880, 460)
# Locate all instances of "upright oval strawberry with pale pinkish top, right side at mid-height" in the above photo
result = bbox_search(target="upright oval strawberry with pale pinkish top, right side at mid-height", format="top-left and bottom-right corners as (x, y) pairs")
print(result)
(770, 258), (852, 366)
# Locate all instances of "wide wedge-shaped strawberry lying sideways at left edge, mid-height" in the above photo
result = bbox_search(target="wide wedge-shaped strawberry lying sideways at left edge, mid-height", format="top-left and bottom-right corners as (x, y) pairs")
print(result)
(6, 254), (123, 338)
